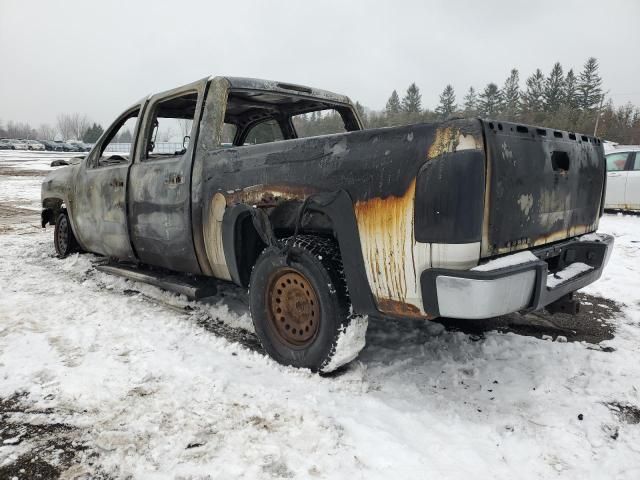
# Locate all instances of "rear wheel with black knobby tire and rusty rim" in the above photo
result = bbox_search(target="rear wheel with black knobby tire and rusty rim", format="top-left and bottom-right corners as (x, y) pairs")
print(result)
(249, 235), (366, 372)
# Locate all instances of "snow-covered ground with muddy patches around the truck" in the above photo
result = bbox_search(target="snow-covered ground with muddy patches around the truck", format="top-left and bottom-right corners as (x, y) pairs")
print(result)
(0, 152), (640, 479)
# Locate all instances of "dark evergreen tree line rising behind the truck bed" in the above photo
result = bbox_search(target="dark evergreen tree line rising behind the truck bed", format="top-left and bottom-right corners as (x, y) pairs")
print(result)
(300, 57), (640, 144)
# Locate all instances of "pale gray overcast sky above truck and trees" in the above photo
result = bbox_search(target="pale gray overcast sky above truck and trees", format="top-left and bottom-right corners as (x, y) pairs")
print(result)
(0, 0), (640, 126)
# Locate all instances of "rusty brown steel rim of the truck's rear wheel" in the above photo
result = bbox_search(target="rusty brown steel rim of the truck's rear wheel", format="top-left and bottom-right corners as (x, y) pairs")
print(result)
(267, 269), (320, 347)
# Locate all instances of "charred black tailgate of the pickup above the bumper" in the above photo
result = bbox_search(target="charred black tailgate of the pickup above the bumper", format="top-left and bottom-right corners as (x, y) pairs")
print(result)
(481, 120), (606, 257)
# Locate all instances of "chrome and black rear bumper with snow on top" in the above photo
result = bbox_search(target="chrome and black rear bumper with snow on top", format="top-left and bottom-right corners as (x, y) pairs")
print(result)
(420, 233), (613, 319)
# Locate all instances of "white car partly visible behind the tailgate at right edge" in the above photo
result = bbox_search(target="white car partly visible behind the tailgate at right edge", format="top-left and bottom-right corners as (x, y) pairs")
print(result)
(604, 145), (640, 211)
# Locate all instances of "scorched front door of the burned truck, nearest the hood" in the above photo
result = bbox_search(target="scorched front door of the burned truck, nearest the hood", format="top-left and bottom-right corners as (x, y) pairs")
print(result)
(70, 102), (144, 260)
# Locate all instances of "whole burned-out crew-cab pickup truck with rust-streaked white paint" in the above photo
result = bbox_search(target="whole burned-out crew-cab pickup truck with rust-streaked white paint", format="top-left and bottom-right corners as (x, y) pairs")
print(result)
(42, 77), (613, 371)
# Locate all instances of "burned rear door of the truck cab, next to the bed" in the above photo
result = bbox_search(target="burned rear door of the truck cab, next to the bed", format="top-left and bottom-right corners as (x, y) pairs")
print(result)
(128, 80), (207, 273)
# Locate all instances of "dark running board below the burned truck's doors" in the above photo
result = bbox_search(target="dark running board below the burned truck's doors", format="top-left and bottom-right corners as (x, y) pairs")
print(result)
(95, 264), (218, 300)
